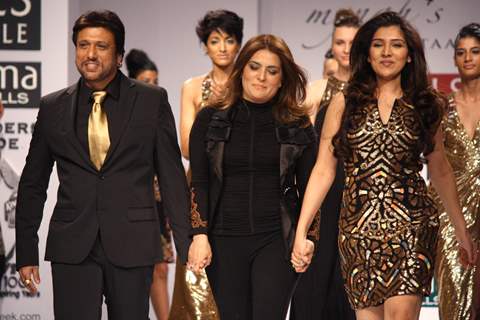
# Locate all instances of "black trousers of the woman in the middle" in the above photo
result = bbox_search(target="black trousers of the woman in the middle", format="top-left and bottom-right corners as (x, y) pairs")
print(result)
(207, 232), (297, 320)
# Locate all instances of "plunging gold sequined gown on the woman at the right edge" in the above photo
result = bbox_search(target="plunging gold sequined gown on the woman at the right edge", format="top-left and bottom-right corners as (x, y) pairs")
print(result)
(432, 97), (480, 320)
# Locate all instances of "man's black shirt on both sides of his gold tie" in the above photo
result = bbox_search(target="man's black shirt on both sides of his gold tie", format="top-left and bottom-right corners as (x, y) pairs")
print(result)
(75, 72), (120, 152)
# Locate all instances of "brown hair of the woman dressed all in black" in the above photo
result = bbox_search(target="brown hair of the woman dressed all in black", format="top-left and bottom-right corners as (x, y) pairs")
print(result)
(213, 34), (310, 126)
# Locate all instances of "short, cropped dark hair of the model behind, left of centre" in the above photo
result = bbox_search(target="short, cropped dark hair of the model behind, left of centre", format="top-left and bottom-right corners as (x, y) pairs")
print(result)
(195, 10), (243, 45)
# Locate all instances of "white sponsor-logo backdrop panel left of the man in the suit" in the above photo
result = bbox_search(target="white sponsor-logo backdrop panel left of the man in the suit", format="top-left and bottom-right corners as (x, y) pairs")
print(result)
(0, 0), (69, 320)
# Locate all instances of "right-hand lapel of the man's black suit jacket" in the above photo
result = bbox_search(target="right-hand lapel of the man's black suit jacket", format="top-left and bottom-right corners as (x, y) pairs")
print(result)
(102, 74), (137, 170)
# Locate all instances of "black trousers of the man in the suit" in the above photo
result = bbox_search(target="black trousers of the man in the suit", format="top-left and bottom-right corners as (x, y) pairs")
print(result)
(52, 237), (153, 320)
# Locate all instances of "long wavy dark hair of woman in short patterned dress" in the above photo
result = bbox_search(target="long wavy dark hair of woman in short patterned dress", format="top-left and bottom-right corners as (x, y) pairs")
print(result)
(333, 12), (446, 161)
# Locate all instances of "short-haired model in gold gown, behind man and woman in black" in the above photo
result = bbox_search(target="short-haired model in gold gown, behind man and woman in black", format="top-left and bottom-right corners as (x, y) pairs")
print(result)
(170, 10), (243, 320)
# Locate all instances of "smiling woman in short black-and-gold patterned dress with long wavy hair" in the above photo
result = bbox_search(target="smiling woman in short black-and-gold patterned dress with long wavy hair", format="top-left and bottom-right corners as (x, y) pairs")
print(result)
(292, 12), (476, 320)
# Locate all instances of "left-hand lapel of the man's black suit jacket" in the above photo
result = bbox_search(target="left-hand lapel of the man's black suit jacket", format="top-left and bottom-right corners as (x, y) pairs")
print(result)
(61, 82), (97, 171)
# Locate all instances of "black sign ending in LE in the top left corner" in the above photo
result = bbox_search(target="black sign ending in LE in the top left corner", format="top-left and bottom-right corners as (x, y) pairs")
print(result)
(0, 0), (41, 50)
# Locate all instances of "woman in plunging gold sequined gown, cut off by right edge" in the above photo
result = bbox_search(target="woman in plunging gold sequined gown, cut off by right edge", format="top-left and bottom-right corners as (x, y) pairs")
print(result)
(433, 23), (480, 320)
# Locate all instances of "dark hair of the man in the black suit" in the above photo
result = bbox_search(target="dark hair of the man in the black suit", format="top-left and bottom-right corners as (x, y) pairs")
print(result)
(72, 10), (125, 56)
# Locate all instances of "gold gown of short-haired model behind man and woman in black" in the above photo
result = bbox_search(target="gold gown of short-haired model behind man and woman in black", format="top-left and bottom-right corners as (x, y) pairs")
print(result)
(169, 74), (220, 320)
